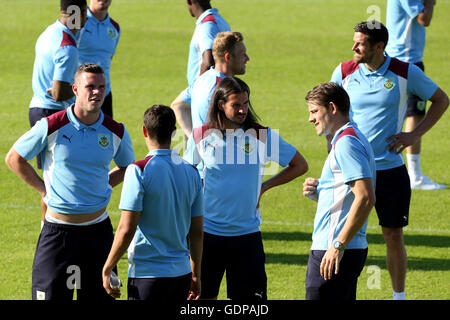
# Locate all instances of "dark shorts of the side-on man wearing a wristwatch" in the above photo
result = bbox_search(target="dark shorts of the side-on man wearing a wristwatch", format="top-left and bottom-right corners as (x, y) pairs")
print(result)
(305, 249), (368, 301)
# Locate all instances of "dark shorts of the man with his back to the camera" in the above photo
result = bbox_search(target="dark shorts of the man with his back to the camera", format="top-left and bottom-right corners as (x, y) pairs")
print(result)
(128, 273), (192, 302)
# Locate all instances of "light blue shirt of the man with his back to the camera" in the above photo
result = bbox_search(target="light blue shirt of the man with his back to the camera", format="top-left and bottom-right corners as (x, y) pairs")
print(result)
(119, 149), (203, 278)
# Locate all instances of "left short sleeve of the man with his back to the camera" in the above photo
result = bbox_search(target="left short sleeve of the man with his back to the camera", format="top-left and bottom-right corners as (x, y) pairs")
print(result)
(119, 164), (145, 212)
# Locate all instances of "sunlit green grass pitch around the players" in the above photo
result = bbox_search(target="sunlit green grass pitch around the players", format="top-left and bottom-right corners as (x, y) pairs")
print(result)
(0, 0), (450, 300)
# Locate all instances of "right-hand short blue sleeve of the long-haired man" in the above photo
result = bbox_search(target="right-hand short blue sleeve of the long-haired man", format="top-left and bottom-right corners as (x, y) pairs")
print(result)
(266, 128), (297, 167)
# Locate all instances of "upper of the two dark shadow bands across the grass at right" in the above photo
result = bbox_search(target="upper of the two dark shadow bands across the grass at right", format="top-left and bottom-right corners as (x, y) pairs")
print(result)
(262, 232), (450, 248)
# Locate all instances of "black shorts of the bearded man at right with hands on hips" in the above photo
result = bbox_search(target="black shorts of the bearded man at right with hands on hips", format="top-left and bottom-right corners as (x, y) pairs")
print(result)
(375, 165), (411, 228)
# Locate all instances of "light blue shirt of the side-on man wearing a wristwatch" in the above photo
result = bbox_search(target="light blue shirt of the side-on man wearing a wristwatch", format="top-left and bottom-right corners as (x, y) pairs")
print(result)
(311, 122), (376, 250)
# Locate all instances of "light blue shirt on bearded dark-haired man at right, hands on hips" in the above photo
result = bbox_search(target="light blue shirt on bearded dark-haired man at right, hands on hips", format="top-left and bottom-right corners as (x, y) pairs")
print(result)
(331, 54), (438, 170)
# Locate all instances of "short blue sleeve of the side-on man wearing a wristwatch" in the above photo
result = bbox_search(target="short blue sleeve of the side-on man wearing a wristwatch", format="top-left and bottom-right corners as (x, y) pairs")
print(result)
(334, 135), (373, 183)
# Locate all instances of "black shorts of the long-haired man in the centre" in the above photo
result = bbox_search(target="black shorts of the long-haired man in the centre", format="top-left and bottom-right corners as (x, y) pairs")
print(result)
(201, 232), (267, 300)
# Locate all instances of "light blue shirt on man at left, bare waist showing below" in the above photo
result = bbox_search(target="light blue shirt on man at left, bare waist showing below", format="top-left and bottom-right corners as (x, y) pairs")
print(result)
(13, 106), (134, 214)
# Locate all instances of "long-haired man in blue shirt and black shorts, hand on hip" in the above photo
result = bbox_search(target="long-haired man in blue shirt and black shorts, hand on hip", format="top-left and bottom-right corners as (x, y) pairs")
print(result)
(184, 77), (308, 300)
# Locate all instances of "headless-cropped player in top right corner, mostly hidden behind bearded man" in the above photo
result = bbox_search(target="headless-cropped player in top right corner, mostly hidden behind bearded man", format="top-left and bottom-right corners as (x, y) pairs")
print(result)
(386, 0), (446, 190)
